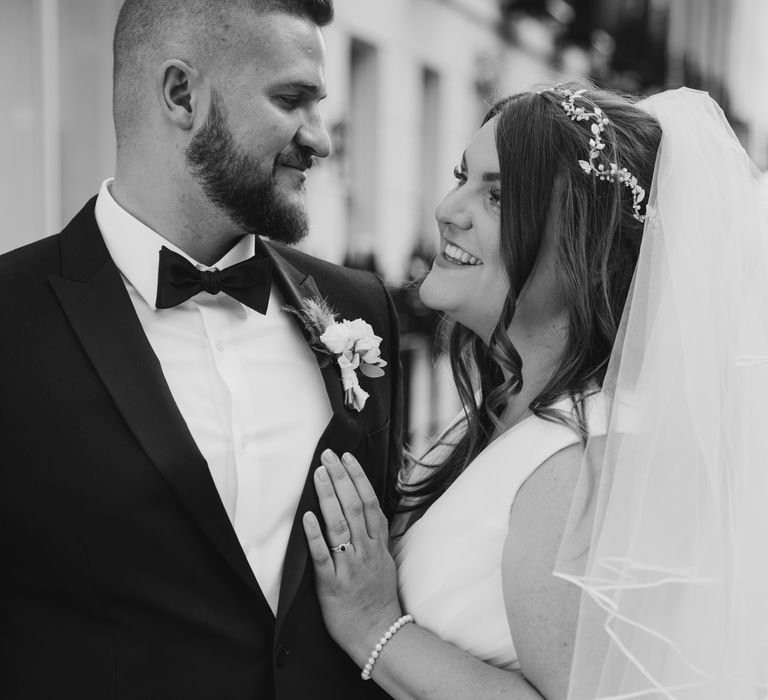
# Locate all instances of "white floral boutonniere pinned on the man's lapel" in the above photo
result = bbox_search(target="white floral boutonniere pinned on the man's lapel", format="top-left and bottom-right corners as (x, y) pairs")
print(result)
(283, 298), (387, 411)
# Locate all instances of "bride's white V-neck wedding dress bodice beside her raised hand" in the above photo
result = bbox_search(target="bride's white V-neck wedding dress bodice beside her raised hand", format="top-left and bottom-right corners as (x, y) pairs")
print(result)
(391, 394), (604, 670)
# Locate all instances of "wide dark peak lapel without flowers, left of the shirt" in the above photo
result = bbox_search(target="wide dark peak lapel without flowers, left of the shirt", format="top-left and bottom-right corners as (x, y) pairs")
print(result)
(50, 200), (267, 608)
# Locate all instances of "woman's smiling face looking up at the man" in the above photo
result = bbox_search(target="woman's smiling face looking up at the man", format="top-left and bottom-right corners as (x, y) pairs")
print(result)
(420, 118), (509, 341)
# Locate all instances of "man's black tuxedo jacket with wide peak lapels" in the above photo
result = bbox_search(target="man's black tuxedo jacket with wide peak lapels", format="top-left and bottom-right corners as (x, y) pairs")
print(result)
(0, 200), (401, 700)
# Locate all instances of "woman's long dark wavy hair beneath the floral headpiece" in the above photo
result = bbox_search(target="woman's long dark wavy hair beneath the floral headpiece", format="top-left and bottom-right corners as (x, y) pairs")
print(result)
(399, 85), (661, 511)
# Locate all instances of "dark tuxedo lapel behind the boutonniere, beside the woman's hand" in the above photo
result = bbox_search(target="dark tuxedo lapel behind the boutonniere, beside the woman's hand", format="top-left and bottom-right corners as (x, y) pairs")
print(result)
(266, 246), (366, 638)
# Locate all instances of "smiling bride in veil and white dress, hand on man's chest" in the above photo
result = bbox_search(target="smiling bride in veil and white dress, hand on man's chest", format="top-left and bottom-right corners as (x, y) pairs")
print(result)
(304, 86), (768, 700)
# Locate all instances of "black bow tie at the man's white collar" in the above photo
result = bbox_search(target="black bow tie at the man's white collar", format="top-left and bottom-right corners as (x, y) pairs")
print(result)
(155, 247), (272, 314)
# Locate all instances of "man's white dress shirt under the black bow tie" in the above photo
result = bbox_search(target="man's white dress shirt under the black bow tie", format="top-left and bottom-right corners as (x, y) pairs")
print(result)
(96, 179), (332, 613)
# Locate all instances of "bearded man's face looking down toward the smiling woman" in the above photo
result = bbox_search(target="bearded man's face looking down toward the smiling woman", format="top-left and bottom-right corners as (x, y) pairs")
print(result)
(186, 14), (330, 243)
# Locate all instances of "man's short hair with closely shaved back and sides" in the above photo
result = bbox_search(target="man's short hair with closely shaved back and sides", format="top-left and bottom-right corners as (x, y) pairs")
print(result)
(112, 0), (333, 144)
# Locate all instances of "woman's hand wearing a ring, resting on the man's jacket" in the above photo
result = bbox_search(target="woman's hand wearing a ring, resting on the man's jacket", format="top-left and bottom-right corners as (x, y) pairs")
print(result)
(304, 450), (402, 666)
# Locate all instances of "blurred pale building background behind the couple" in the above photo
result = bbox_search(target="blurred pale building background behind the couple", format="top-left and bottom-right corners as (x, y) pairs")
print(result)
(0, 0), (768, 450)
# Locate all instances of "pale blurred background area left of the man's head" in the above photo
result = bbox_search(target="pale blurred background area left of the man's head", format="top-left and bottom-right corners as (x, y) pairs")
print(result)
(0, 0), (122, 252)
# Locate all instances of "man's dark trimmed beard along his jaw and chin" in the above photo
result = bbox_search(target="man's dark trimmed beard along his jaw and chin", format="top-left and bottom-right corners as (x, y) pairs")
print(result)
(186, 91), (312, 245)
